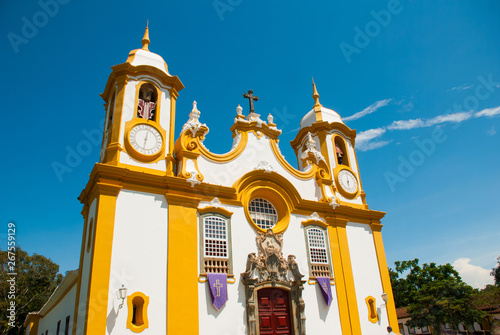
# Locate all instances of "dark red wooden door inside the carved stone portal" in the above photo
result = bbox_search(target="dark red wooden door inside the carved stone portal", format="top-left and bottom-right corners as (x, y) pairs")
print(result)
(257, 288), (292, 335)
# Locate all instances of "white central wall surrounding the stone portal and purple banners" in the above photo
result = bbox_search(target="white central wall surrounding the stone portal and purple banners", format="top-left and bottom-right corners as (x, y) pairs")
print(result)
(198, 206), (341, 335)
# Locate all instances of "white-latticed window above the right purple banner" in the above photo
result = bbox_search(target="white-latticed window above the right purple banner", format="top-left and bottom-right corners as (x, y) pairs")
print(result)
(306, 226), (332, 277)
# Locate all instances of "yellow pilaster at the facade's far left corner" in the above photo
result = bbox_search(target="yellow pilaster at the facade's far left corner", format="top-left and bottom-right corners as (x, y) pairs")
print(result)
(84, 183), (121, 334)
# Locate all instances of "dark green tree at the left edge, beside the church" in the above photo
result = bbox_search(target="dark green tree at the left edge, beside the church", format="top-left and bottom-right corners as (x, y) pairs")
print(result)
(0, 246), (62, 335)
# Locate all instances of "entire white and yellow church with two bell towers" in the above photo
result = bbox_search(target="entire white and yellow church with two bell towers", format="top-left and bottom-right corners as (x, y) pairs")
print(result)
(25, 28), (398, 335)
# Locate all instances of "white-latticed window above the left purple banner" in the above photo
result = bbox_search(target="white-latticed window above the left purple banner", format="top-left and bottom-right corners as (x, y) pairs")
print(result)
(201, 214), (231, 274)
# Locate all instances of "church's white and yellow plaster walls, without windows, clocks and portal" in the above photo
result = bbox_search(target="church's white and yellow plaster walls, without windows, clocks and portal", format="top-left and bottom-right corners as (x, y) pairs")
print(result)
(27, 28), (397, 335)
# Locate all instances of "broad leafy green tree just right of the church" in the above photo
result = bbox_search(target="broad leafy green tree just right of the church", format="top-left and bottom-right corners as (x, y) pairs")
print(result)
(390, 259), (483, 334)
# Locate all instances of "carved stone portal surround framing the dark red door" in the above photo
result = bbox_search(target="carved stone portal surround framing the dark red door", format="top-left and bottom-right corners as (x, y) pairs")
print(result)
(241, 229), (306, 335)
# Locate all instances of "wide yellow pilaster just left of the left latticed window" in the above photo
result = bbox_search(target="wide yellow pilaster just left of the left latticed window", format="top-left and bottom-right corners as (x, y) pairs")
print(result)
(166, 203), (199, 334)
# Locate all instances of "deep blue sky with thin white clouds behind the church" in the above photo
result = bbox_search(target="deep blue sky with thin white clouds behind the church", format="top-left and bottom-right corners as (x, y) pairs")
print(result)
(0, 0), (500, 286)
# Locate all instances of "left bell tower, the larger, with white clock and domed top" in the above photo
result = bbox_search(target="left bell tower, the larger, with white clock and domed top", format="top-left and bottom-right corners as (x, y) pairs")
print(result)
(100, 27), (184, 176)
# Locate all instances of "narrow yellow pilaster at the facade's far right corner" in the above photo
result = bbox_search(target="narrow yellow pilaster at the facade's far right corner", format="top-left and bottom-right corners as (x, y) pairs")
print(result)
(370, 223), (398, 329)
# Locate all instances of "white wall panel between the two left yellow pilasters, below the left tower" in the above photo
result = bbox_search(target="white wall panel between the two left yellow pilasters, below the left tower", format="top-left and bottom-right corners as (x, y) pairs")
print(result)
(107, 190), (168, 335)
